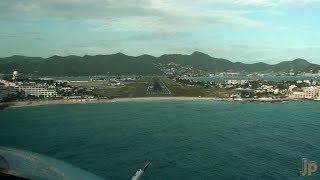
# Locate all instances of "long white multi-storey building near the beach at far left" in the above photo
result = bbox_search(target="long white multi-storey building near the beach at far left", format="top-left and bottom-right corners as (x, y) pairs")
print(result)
(17, 86), (57, 97)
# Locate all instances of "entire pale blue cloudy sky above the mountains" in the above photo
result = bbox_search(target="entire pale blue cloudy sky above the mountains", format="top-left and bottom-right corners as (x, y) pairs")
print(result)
(0, 0), (320, 64)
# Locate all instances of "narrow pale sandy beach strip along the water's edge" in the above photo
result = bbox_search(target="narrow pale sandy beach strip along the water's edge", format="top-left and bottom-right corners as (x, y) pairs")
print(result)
(0, 97), (317, 109)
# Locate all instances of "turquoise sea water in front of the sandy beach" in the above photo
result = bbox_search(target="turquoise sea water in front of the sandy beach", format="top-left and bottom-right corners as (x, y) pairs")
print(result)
(0, 101), (320, 180)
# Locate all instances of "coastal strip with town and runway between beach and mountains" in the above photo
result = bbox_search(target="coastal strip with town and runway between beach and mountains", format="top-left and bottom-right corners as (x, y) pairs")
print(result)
(0, 70), (320, 107)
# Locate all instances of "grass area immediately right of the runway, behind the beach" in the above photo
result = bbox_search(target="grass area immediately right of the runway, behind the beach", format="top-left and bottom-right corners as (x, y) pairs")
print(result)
(161, 77), (229, 97)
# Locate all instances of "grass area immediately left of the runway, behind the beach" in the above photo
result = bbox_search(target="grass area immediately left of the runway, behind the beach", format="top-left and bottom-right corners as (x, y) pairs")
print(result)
(94, 77), (151, 98)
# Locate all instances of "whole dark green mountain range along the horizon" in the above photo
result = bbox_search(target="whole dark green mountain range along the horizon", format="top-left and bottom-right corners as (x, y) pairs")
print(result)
(0, 52), (320, 76)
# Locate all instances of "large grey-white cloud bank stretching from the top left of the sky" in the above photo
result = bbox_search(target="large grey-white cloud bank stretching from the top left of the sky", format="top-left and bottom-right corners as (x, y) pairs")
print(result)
(0, 0), (265, 31)
